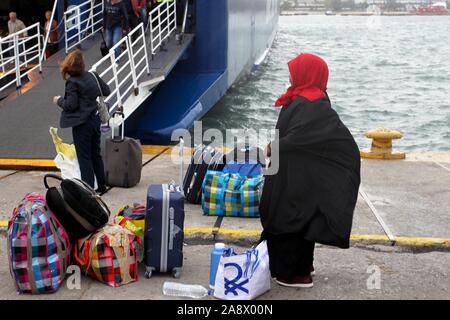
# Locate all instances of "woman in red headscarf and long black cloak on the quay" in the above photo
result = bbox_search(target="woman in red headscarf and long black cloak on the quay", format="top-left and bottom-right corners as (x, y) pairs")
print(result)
(260, 53), (360, 288)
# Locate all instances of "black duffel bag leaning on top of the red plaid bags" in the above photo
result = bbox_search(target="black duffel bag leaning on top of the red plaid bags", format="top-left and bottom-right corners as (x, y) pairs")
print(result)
(44, 174), (111, 241)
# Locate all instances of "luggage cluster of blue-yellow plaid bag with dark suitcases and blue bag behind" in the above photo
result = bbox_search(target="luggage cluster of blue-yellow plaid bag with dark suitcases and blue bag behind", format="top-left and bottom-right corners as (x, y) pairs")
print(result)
(183, 145), (263, 218)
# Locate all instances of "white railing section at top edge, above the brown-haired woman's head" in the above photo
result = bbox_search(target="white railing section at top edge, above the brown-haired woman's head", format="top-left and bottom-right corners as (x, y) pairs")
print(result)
(64, 0), (104, 53)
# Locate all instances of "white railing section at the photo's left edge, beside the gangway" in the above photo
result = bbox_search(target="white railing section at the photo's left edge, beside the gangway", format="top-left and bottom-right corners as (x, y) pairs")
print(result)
(0, 23), (42, 92)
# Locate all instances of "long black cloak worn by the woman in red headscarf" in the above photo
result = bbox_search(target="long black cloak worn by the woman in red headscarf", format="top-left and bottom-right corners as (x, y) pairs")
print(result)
(260, 97), (361, 248)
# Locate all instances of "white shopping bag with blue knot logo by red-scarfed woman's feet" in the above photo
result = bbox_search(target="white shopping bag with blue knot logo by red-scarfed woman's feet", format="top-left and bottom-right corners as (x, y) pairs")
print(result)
(214, 241), (271, 300)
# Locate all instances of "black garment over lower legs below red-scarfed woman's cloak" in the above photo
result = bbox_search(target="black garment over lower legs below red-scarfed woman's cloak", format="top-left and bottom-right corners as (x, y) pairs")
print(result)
(261, 232), (315, 279)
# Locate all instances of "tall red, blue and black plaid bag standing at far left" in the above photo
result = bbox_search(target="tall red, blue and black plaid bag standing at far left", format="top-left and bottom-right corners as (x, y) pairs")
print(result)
(7, 193), (70, 294)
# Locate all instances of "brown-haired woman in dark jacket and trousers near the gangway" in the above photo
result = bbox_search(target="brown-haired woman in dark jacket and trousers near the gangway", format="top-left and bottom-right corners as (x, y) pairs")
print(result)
(53, 50), (111, 193)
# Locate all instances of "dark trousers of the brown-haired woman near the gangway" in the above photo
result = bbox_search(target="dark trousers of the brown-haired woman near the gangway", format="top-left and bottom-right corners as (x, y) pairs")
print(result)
(72, 114), (106, 188)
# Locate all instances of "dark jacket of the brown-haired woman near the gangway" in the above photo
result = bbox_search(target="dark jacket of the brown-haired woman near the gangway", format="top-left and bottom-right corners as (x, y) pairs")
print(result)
(58, 72), (111, 128)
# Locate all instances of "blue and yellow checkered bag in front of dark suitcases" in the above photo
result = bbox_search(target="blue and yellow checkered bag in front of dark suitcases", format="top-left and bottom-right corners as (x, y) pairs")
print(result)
(202, 171), (263, 218)
